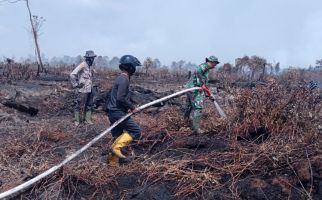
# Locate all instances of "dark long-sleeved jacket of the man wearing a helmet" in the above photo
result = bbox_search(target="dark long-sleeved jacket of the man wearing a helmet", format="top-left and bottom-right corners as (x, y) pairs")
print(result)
(107, 73), (135, 112)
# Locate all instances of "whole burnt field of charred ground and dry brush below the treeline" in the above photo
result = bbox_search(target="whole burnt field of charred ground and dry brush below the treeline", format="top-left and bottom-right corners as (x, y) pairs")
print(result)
(0, 66), (322, 200)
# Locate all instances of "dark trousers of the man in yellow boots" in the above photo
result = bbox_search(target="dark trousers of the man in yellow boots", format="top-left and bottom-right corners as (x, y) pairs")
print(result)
(107, 110), (141, 139)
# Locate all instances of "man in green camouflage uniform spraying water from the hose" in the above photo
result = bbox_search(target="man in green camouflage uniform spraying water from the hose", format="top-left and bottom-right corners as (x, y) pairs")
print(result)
(184, 56), (219, 134)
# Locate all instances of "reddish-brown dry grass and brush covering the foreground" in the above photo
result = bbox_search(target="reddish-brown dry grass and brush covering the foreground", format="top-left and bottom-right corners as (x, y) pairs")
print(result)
(0, 65), (322, 199)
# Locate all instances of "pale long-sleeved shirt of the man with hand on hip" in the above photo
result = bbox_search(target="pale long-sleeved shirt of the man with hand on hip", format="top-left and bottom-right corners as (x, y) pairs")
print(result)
(70, 61), (93, 93)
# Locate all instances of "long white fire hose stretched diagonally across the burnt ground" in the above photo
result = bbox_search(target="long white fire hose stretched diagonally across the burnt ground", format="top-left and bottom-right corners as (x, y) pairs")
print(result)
(0, 87), (200, 199)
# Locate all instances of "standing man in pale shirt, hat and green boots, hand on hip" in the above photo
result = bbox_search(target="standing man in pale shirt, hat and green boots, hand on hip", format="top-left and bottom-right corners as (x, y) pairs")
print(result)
(70, 50), (96, 126)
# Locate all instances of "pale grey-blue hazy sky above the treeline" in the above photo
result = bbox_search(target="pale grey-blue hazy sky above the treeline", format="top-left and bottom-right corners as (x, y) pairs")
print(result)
(0, 0), (322, 67)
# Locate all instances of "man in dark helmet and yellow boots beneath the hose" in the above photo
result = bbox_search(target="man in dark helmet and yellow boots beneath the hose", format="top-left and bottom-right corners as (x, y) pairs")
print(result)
(107, 55), (141, 166)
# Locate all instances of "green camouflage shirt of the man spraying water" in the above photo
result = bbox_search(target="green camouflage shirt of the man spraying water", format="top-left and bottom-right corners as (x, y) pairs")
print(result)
(186, 63), (209, 88)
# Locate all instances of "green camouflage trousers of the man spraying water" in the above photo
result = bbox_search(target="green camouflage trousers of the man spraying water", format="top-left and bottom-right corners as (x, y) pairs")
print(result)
(184, 90), (205, 131)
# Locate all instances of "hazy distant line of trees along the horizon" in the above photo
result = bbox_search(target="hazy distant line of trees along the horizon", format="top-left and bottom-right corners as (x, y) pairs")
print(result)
(0, 55), (322, 75)
